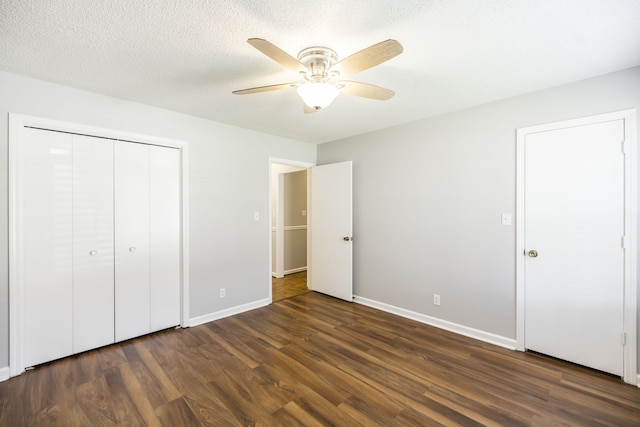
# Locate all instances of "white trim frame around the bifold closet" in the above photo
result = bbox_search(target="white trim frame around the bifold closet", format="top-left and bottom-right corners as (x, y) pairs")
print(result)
(8, 113), (189, 377)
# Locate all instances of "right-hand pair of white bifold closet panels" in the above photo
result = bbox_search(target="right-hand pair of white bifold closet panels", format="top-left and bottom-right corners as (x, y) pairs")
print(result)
(114, 141), (180, 341)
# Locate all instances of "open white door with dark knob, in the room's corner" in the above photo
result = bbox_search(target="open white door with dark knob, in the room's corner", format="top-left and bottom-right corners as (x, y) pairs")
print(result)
(308, 162), (353, 301)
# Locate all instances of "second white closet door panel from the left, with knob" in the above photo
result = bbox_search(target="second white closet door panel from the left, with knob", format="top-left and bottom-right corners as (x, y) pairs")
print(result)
(73, 135), (114, 353)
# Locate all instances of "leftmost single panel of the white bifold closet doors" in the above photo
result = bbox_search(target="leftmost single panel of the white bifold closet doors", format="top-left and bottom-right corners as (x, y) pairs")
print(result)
(20, 129), (73, 366)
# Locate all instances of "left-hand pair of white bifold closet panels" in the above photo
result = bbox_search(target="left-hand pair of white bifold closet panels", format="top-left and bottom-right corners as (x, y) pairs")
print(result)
(21, 129), (114, 366)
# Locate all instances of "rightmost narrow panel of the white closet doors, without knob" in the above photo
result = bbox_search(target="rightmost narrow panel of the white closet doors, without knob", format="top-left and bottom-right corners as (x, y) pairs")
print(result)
(149, 146), (180, 331)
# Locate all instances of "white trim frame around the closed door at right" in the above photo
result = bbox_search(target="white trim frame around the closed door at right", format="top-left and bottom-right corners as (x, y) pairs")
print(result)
(516, 109), (638, 385)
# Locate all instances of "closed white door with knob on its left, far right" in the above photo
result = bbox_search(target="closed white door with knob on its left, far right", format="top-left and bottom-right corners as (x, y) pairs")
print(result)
(523, 120), (625, 375)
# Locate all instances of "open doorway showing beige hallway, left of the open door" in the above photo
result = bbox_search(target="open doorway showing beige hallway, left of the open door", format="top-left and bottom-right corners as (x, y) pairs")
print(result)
(270, 160), (312, 302)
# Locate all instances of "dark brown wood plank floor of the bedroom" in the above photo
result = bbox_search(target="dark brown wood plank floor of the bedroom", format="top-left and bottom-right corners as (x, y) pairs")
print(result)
(0, 292), (640, 427)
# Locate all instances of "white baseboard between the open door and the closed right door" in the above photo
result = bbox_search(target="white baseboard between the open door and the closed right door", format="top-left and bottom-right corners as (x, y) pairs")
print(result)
(353, 295), (516, 350)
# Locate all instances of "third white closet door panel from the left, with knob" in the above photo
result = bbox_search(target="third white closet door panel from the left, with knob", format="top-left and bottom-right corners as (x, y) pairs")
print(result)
(114, 141), (150, 341)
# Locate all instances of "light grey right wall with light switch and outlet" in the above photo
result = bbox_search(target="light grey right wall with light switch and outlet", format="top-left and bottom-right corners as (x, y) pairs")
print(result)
(318, 67), (640, 364)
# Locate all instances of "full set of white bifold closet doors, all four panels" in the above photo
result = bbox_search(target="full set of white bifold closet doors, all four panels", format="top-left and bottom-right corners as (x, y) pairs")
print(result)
(13, 128), (181, 367)
